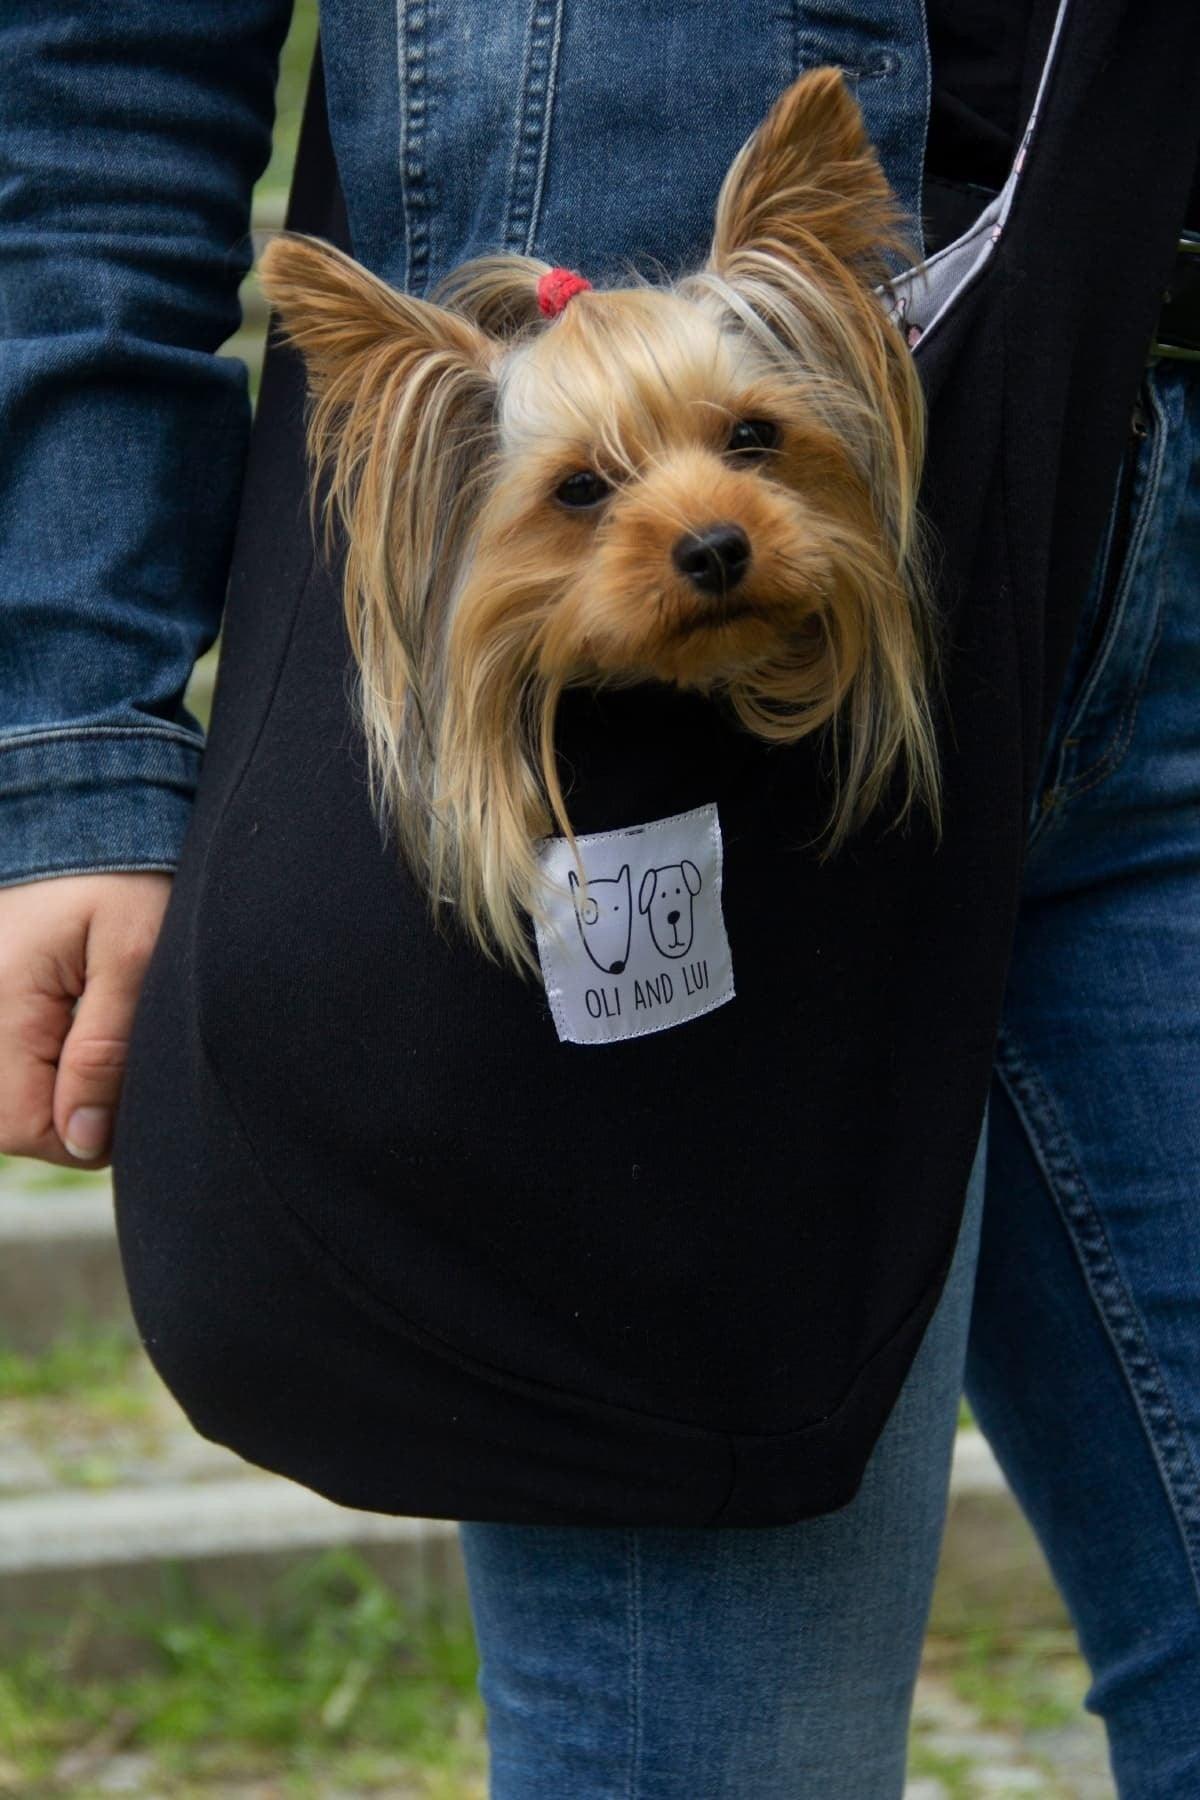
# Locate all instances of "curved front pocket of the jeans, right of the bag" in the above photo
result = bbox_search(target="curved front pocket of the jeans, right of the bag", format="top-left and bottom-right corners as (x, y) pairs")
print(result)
(1031, 380), (1169, 841)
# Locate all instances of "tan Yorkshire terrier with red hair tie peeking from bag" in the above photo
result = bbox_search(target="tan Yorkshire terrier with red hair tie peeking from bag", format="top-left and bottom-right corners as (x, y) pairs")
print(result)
(259, 68), (941, 976)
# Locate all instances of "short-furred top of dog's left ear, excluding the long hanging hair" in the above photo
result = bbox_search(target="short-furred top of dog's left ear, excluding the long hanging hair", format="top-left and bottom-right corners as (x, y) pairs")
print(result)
(257, 232), (495, 396)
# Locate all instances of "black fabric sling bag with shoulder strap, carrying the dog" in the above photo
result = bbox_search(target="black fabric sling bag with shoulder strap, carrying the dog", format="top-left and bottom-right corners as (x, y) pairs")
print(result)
(113, 0), (1200, 1525)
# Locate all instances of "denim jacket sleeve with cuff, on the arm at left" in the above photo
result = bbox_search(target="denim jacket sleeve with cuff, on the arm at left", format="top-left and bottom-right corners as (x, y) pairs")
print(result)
(0, 0), (291, 886)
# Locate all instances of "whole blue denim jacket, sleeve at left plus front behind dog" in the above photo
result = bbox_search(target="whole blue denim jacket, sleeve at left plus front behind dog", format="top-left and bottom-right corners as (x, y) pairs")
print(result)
(0, 0), (928, 886)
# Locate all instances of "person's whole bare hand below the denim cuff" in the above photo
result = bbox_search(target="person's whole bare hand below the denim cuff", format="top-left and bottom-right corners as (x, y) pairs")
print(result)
(0, 873), (171, 1168)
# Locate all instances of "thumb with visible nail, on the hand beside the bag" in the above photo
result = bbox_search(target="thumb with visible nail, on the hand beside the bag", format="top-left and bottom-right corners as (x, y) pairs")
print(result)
(54, 920), (154, 1163)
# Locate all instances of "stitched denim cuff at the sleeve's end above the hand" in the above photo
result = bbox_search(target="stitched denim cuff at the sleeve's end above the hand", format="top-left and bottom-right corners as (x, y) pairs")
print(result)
(0, 724), (203, 887)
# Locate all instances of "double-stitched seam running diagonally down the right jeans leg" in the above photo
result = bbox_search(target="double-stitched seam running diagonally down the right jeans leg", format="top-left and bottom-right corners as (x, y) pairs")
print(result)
(995, 1031), (1200, 1598)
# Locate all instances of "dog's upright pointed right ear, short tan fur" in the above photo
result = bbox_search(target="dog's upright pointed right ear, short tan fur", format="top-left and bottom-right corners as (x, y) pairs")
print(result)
(709, 68), (914, 281)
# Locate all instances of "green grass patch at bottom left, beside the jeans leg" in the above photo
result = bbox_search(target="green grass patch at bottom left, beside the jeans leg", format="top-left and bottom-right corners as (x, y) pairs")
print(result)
(0, 1550), (484, 1796)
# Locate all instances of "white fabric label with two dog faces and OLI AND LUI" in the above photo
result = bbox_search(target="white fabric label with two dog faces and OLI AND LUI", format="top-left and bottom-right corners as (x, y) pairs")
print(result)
(534, 805), (734, 1044)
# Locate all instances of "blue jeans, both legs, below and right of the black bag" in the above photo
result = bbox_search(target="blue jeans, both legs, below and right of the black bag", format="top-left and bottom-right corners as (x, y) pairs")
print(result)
(462, 362), (1200, 1800)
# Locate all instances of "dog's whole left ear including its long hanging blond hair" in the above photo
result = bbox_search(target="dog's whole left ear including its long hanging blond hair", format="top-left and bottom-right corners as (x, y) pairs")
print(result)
(259, 234), (498, 936)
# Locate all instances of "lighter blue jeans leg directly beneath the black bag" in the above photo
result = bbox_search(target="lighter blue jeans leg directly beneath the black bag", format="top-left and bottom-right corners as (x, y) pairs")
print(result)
(461, 1116), (988, 1800)
